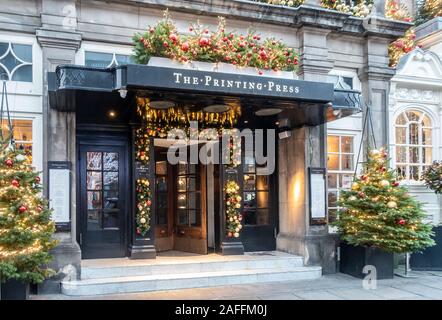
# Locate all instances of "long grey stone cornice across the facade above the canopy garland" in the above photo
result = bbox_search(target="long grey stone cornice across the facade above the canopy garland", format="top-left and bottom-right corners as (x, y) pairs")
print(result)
(120, 0), (412, 39)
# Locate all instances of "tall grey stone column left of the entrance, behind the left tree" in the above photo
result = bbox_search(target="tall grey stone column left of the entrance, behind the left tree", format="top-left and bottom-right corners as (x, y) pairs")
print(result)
(36, 0), (81, 292)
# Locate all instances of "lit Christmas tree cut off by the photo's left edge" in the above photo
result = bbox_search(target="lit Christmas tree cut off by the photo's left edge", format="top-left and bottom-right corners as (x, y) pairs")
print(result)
(0, 138), (56, 300)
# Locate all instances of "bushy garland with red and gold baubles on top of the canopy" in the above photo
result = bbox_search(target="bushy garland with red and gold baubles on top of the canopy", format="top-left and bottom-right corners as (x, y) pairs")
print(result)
(133, 10), (298, 74)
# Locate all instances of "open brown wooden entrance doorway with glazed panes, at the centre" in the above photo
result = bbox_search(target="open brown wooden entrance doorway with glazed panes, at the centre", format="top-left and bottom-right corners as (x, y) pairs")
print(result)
(154, 140), (207, 254)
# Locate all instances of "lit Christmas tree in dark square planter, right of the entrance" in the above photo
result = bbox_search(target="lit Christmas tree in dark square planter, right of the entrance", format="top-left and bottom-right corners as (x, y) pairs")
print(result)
(334, 149), (434, 279)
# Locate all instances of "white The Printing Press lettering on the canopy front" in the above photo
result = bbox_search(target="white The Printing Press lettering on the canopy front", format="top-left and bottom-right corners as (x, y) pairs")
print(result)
(173, 72), (300, 94)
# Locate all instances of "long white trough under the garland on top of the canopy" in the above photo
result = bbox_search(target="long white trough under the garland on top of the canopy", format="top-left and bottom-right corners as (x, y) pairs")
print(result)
(147, 57), (298, 79)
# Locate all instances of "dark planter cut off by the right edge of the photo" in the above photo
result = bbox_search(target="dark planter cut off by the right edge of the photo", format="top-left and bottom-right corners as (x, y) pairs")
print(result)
(410, 226), (442, 271)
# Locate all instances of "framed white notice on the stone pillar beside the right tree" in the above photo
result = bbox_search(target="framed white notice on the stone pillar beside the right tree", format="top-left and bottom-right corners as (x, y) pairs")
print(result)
(309, 168), (327, 225)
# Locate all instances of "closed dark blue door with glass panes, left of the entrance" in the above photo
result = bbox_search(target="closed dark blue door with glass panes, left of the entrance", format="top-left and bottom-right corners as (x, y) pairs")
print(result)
(79, 145), (129, 259)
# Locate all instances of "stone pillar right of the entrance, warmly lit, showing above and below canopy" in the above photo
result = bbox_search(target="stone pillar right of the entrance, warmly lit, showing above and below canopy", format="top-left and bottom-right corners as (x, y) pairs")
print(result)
(277, 27), (336, 273)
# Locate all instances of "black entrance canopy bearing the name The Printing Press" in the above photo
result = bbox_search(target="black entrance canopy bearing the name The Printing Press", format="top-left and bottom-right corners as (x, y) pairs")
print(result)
(48, 64), (361, 129)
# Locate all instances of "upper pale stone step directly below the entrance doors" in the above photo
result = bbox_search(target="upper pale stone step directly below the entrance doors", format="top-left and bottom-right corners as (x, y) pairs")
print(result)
(81, 254), (303, 280)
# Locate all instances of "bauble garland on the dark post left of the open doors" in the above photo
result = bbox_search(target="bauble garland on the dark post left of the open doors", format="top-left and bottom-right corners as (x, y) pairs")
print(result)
(135, 127), (152, 237)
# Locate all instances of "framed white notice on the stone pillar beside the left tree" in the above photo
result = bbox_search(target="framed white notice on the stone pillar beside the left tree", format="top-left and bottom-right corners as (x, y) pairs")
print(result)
(48, 161), (71, 231)
